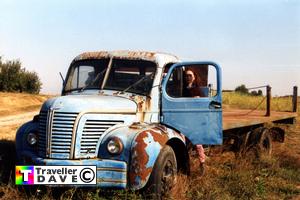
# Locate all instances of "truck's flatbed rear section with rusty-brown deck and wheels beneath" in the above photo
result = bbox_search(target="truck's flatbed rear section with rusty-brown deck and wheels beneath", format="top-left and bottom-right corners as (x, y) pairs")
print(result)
(223, 109), (297, 155)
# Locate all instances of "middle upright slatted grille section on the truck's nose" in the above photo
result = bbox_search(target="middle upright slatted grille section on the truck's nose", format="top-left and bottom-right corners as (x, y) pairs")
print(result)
(50, 112), (77, 158)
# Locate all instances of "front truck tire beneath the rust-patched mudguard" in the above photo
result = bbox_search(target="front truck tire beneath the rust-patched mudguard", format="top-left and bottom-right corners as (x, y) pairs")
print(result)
(146, 145), (177, 199)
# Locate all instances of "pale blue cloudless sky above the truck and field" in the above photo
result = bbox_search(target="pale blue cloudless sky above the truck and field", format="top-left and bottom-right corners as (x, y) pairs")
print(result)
(0, 0), (300, 95)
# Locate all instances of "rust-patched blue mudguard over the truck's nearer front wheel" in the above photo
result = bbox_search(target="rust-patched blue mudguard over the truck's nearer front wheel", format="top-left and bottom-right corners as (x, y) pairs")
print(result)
(129, 125), (185, 190)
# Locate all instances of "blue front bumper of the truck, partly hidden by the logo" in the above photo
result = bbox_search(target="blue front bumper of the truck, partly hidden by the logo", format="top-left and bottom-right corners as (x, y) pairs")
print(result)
(21, 151), (127, 189)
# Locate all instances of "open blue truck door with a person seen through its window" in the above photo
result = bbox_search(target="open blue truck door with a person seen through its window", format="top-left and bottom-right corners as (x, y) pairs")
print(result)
(161, 62), (223, 144)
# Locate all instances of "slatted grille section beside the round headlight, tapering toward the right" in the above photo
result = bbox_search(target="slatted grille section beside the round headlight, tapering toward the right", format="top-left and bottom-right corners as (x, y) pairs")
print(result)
(80, 120), (124, 155)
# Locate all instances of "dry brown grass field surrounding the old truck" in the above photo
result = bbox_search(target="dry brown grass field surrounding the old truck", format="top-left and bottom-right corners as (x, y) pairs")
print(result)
(0, 93), (300, 200)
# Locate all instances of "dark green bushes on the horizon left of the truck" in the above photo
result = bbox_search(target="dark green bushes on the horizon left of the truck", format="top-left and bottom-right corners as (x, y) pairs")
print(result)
(0, 57), (42, 94)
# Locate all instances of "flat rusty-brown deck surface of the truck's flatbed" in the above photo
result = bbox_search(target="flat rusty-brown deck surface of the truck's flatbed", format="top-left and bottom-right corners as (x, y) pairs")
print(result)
(223, 109), (297, 131)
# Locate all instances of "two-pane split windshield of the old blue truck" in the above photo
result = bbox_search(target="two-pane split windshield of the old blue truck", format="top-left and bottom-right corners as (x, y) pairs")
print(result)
(64, 59), (156, 95)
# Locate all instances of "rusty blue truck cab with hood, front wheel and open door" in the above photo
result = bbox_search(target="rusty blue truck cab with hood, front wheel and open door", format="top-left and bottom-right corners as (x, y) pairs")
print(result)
(16, 51), (222, 193)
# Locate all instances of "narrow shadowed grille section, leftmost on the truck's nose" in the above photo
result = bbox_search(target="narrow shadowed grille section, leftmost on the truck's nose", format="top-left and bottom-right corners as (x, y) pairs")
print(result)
(38, 111), (47, 158)
